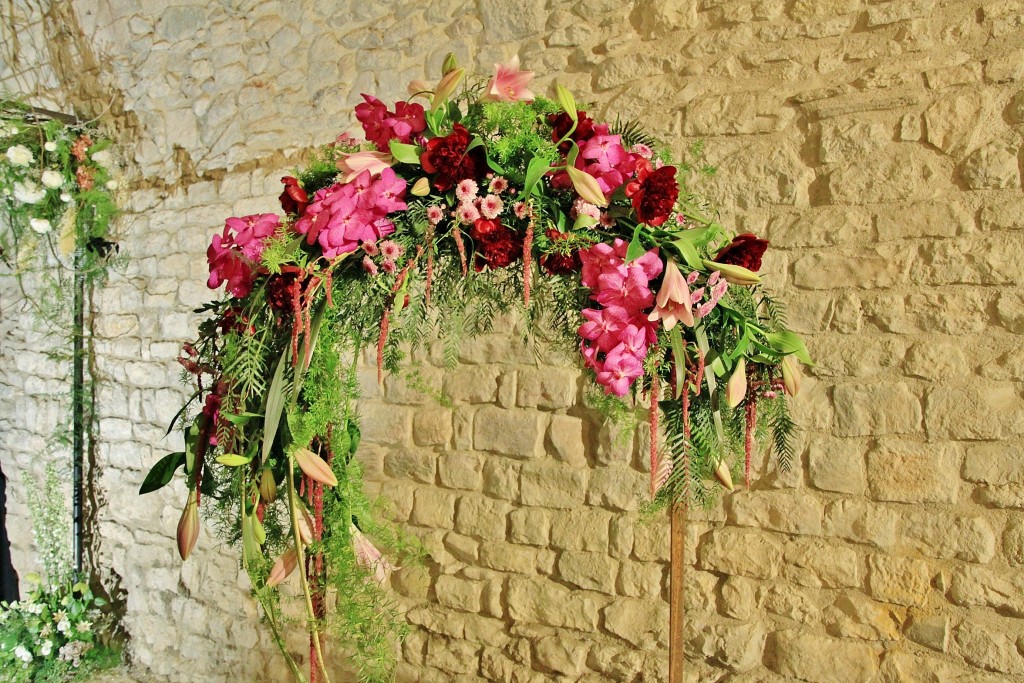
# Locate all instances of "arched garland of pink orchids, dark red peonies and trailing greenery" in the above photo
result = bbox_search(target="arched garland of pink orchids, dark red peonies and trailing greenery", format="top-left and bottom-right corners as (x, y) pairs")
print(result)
(142, 56), (809, 680)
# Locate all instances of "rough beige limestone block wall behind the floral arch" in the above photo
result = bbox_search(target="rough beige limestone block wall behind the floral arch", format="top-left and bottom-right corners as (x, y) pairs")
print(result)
(0, 0), (1024, 682)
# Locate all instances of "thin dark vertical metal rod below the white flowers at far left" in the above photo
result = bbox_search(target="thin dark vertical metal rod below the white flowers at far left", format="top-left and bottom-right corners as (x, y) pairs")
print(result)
(72, 249), (85, 573)
